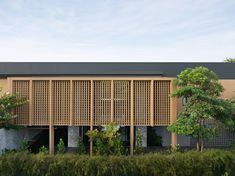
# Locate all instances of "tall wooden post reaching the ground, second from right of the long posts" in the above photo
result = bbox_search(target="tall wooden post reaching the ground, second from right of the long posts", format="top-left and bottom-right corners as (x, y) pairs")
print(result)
(130, 80), (134, 156)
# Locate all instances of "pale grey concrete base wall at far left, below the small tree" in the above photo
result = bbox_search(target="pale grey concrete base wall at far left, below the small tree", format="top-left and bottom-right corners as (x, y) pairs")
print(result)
(0, 128), (41, 152)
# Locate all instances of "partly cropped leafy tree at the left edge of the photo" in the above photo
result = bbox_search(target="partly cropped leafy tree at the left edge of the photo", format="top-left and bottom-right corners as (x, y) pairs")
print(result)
(0, 89), (27, 129)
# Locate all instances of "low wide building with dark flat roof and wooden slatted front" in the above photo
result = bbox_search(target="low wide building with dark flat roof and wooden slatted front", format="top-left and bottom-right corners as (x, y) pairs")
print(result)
(0, 62), (235, 154)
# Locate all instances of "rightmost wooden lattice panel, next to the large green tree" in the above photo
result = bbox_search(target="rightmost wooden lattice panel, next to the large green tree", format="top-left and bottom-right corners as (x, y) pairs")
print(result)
(154, 81), (171, 125)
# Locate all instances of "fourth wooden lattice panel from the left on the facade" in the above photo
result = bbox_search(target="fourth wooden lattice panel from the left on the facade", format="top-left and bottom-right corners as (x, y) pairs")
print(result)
(73, 80), (91, 126)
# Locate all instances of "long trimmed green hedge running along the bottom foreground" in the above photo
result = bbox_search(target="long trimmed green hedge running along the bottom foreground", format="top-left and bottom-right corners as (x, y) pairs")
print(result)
(0, 150), (235, 176)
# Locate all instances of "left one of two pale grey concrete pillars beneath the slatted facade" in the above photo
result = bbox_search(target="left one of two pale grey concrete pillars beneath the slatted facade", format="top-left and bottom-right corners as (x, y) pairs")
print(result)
(68, 126), (79, 147)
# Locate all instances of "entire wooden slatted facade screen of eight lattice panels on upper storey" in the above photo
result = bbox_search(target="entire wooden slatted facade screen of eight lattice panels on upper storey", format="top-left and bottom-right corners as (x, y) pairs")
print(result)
(9, 77), (175, 126)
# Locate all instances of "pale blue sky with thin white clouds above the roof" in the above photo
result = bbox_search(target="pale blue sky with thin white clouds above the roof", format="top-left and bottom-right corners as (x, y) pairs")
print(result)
(0, 0), (235, 62)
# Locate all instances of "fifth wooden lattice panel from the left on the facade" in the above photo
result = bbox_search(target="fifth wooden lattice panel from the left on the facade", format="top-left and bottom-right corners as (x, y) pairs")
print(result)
(94, 80), (111, 125)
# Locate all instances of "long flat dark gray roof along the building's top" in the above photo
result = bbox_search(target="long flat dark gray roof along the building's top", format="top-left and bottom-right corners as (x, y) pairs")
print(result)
(0, 62), (235, 79)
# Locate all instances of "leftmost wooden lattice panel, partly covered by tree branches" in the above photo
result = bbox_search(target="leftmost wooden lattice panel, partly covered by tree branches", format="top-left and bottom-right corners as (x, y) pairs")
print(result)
(12, 80), (30, 125)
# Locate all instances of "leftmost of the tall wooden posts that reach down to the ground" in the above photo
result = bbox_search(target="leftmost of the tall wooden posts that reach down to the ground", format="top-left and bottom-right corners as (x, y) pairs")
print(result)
(49, 80), (55, 155)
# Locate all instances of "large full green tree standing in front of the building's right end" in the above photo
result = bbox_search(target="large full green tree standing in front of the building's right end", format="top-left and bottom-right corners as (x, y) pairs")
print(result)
(168, 67), (235, 151)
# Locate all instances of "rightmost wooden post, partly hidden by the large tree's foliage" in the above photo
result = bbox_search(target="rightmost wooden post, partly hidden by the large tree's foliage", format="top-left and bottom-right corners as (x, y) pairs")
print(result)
(170, 80), (177, 147)
